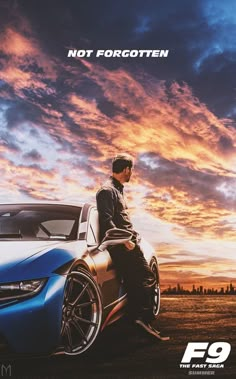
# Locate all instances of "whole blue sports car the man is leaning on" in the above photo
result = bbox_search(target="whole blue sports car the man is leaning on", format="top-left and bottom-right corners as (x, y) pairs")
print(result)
(0, 203), (160, 355)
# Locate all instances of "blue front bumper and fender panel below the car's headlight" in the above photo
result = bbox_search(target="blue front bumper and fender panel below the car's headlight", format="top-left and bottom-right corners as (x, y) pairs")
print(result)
(0, 275), (66, 353)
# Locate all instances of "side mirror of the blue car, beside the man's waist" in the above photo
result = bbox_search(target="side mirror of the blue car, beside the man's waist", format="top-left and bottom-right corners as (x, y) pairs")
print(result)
(98, 228), (133, 251)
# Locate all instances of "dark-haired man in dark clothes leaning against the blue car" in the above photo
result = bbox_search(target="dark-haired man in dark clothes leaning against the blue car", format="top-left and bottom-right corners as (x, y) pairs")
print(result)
(96, 154), (168, 339)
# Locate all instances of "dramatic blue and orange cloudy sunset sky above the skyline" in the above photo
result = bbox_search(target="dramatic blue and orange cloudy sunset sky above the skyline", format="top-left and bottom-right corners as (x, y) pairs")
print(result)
(0, 0), (236, 288)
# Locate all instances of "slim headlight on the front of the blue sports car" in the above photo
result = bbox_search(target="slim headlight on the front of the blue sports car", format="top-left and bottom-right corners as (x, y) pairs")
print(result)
(0, 279), (47, 300)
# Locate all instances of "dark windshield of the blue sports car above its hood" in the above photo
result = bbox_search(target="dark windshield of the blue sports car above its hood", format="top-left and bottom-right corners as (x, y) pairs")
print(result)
(0, 204), (81, 241)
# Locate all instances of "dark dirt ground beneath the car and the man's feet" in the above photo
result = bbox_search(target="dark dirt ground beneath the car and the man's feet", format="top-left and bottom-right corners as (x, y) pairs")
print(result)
(0, 296), (236, 379)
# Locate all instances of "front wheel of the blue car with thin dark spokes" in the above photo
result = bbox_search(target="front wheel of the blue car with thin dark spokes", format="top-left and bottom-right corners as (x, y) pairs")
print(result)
(61, 268), (103, 355)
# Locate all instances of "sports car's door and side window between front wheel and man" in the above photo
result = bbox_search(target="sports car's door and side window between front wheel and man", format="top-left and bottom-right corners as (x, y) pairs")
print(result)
(87, 207), (122, 306)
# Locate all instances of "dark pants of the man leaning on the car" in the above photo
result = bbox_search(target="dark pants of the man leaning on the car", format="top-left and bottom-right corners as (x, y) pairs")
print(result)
(109, 244), (156, 322)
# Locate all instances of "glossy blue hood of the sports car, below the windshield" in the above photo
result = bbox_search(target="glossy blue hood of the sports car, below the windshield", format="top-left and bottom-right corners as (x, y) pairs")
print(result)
(0, 241), (86, 283)
